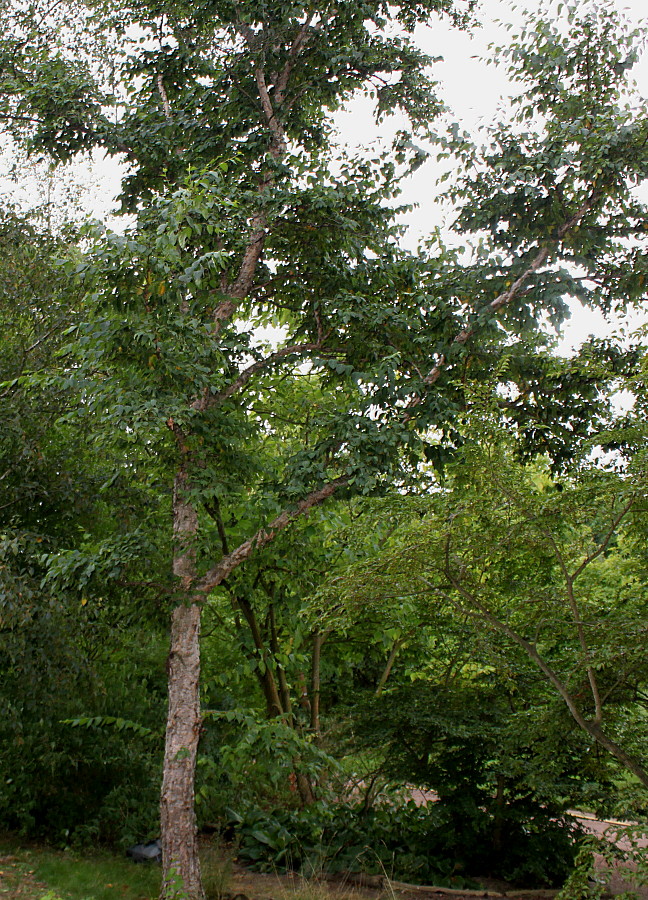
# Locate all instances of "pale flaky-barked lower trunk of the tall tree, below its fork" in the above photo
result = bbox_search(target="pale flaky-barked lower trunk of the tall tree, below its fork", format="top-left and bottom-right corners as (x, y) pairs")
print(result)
(160, 604), (205, 900)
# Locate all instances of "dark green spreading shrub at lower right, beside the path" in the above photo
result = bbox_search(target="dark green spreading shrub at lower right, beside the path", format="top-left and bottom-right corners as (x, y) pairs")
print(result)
(354, 684), (613, 884)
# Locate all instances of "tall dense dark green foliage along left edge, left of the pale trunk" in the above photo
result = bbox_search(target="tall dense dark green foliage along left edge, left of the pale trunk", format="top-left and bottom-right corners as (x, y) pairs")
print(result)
(0, 211), (170, 844)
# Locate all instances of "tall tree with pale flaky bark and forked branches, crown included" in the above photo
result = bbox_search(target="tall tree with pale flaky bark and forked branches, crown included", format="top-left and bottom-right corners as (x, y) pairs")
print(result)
(1, 0), (646, 900)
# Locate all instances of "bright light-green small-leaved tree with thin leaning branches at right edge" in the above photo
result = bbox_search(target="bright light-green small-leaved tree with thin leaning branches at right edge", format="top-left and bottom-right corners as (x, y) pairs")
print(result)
(326, 421), (648, 787)
